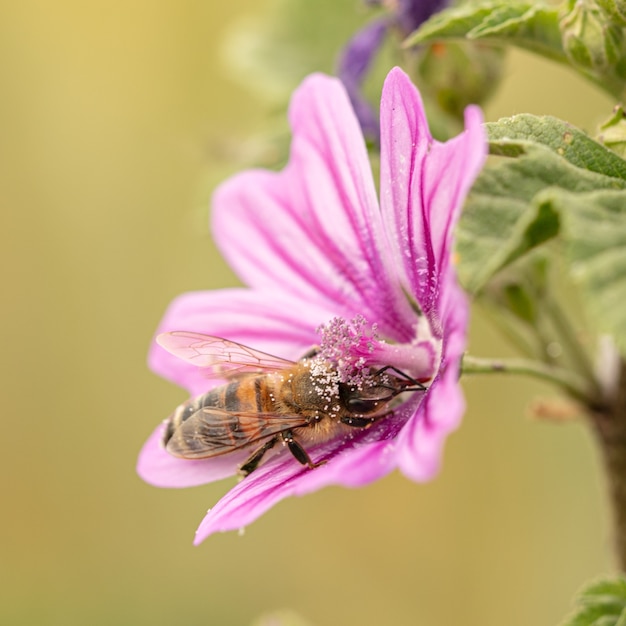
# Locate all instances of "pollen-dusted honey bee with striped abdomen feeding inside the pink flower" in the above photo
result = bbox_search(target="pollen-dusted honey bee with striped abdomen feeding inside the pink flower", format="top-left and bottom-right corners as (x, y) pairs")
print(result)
(157, 331), (426, 476)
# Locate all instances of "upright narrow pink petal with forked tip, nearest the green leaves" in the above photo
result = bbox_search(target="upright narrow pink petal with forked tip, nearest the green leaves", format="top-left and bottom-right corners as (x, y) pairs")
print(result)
(381, 68), (487, 322)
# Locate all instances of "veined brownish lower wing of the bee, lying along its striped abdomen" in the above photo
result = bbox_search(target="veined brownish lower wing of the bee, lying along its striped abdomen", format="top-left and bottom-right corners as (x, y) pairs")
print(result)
(166, 407), (307, 459)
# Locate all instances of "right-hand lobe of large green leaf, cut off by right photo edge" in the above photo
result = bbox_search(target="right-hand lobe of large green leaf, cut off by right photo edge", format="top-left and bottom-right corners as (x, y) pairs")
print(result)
(537, 189), (626, 356)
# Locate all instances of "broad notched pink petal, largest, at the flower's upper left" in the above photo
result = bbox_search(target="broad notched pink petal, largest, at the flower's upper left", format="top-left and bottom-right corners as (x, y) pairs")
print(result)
(213, 75), (412, 340)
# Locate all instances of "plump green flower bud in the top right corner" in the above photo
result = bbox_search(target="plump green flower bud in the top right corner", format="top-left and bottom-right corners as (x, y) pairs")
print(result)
(560, 0), (626, 76)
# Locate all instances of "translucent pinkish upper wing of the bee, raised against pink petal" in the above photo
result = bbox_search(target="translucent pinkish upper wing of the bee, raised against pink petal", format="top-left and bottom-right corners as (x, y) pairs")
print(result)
(156, 330), (294, 378)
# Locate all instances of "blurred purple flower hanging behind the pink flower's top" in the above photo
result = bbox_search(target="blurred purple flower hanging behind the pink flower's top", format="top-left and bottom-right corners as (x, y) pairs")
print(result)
(337, 0), (448, 141)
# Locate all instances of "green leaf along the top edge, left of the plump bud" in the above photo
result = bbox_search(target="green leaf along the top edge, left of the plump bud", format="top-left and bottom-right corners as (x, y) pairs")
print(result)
(405, 2), (567, 63)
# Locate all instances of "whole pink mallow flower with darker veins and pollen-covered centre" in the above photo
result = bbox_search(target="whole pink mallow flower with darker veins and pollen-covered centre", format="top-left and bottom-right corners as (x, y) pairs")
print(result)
(138, 68), (487, 544)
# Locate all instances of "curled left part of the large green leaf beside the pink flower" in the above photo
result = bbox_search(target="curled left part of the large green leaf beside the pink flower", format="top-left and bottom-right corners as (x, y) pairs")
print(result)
(457, 132), (626, 293)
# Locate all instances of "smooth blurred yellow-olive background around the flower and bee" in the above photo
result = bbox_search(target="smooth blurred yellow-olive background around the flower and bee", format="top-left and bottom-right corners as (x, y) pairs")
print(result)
(0, 0), (612, 626)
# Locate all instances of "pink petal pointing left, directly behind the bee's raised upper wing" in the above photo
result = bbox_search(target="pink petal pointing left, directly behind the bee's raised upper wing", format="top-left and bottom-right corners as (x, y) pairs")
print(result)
(148, 289), (334, 396)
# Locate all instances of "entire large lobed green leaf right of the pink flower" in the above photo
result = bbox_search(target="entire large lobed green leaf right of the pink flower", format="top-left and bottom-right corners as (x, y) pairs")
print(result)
(457, 115), (626, 354)
